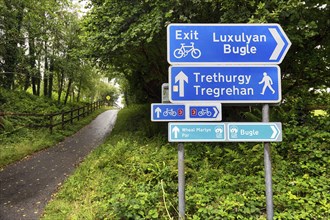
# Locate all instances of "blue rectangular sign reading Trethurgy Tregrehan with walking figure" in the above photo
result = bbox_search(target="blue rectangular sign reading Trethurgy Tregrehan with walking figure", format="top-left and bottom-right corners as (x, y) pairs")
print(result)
(169, 66), (282, 103)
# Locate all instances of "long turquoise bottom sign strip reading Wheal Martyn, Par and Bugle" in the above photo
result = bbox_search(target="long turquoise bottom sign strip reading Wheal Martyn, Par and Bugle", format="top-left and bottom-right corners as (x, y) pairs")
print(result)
(168, 122), (282, 142)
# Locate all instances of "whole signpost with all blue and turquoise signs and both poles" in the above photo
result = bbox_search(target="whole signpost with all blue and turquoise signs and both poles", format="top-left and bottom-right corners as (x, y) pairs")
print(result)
(160, 24), (291, 220)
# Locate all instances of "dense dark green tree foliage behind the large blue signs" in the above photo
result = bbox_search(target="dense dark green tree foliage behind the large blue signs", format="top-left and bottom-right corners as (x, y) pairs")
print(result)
(84, 0), (330, 110)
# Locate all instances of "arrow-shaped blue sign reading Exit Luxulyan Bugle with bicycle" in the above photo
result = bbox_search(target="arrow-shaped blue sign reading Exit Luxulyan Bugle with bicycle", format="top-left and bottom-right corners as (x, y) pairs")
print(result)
(167, 24), (291, 64)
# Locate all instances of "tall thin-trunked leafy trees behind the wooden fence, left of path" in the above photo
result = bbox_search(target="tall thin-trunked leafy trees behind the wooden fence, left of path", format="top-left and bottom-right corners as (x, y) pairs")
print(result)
(0, 0), (118, 103)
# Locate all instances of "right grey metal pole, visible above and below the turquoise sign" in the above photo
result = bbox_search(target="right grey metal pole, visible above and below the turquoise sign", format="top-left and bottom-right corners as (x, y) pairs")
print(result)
(262, 104), (274, 220)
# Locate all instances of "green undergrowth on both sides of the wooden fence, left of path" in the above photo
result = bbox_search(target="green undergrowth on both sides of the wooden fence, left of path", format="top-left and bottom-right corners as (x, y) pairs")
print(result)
(0, 88), (105, 169)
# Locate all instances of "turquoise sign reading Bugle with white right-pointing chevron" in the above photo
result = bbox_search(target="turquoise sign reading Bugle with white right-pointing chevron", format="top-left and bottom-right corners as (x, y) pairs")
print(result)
(227, 123), (282, 142)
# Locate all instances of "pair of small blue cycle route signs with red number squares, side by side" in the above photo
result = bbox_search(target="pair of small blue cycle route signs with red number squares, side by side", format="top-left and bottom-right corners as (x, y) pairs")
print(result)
(151, 103), (222, 122)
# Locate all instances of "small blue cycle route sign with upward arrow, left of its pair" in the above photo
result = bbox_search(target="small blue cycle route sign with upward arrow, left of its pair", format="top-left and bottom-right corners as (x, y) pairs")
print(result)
(151, 103), (186, 121)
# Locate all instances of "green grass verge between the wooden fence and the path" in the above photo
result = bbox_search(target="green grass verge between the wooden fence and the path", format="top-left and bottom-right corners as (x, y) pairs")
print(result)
(0, 108), (106, 168)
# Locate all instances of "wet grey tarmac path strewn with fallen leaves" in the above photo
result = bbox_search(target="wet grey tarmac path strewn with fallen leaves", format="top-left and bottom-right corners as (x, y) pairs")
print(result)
(0, 110), (117, 220)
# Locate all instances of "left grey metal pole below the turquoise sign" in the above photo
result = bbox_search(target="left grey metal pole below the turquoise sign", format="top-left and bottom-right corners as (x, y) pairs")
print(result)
(178, 143), (186, 220)
